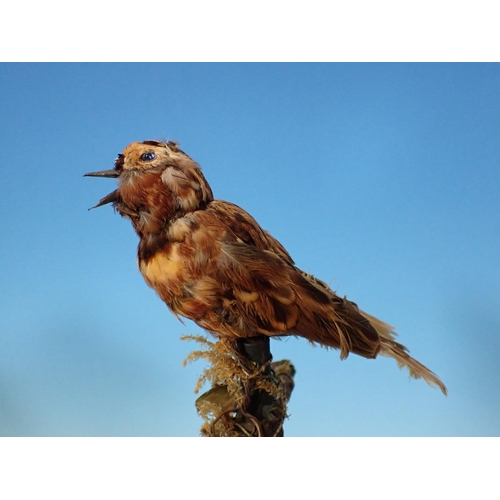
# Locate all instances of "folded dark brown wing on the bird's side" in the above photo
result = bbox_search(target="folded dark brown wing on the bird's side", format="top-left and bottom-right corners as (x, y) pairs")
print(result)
(218, 242), (380, 358)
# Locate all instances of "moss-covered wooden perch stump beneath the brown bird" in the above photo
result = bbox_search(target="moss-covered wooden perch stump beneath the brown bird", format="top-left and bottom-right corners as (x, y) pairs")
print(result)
(188, 335), (295, 437)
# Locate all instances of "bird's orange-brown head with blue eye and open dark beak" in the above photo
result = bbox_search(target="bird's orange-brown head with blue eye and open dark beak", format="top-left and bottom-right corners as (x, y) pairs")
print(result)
(85, 141), (213, 226)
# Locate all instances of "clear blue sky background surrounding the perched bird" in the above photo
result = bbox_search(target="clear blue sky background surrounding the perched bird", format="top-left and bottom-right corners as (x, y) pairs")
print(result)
(0, 64), (500, 436)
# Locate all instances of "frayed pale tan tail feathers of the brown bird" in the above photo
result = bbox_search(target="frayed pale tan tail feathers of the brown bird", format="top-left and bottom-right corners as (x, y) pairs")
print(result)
(359, 310), (447, 396)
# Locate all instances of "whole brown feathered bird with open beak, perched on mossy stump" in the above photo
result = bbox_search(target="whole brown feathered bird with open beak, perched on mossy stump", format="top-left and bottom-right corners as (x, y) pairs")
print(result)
(85, 141), (446, 394)
